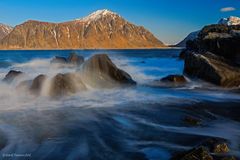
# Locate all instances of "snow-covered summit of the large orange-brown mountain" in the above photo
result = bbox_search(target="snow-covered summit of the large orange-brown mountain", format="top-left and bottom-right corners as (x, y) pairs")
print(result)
(77, 9), (120, 21)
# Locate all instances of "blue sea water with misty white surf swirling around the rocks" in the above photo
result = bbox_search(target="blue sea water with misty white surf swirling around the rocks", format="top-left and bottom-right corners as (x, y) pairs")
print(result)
(0, 49), (240, 160)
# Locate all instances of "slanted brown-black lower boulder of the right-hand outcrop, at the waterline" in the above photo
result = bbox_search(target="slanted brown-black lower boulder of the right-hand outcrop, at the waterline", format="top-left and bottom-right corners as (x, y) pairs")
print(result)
(184, 52), (240, 87)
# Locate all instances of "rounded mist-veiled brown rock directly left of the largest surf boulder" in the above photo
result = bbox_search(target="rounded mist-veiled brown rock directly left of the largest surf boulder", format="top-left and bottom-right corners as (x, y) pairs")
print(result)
(49, 73), (86, 97)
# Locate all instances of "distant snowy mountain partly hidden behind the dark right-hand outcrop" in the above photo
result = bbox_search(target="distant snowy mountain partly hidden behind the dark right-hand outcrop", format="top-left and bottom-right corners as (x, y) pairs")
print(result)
(175, 16), (240, 47)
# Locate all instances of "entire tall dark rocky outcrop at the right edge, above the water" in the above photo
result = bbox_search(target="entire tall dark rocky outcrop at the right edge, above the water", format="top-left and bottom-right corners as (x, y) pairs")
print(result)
(182, 24), (240, 88)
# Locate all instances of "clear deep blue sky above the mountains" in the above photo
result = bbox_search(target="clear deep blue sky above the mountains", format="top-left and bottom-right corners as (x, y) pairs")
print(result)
(0, 0), (240, 44)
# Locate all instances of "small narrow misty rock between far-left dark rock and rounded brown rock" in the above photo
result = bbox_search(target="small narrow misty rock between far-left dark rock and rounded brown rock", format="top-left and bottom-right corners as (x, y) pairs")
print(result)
(30, 74), (47, 94)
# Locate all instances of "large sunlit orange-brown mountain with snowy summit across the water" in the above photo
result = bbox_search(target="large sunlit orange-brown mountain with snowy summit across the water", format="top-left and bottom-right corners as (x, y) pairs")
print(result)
(0, 10), (165, 49)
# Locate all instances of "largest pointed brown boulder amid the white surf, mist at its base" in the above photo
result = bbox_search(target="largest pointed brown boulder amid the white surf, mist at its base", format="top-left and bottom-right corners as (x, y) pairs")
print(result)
(81, 54), (136, 87)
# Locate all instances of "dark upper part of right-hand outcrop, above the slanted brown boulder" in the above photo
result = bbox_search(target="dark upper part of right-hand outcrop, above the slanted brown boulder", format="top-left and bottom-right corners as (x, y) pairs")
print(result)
(187, 25), (240, 64)
